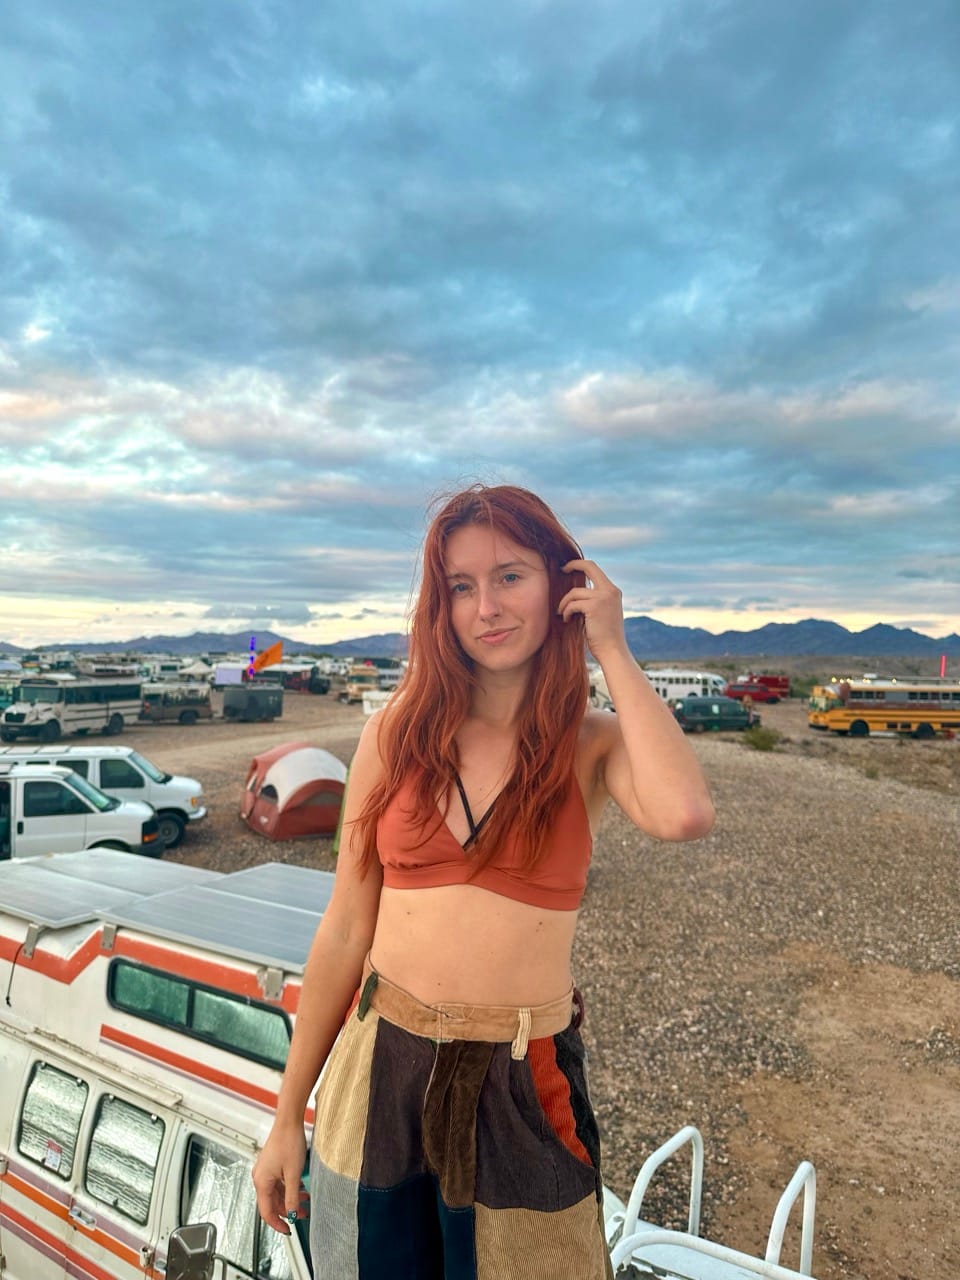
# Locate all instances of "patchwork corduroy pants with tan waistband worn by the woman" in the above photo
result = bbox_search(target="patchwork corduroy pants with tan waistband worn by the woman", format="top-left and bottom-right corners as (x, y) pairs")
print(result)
(310, 960), (612, 1280)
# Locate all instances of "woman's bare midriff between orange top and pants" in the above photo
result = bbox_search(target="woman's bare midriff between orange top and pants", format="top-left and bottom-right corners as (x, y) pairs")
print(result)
(370, 884), (577, 1006)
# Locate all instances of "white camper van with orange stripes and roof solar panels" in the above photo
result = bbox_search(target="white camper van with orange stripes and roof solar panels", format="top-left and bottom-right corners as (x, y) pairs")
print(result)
(0, 850), (333, 1280)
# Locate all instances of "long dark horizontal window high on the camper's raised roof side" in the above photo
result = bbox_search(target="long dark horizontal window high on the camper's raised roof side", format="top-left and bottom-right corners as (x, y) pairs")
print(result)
(108, 960), (291, 1069)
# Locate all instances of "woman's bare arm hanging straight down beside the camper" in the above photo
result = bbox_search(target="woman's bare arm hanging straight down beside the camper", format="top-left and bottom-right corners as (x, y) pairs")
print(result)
(253, 714), (383, 1234)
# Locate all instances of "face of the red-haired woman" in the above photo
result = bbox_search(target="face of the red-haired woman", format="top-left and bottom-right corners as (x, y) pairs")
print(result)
(444, 525), (550, 672)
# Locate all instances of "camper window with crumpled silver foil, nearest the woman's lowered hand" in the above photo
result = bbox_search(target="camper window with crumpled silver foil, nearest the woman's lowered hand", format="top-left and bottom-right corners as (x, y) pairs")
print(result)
(180, 1137), (299, 1280)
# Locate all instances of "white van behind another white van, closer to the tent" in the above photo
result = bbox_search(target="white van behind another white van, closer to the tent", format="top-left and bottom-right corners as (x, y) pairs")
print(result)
(0, 744), (206, 849)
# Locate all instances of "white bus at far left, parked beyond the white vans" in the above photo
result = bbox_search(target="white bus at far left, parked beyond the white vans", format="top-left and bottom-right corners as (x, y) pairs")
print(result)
(0, 673), (143, 742)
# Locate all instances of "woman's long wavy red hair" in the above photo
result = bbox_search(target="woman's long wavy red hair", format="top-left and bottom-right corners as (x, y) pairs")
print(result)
(357, 484), (588, 873)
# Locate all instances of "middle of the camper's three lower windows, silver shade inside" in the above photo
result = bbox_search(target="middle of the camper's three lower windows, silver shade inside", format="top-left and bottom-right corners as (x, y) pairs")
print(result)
(84, 1094), (165, 1224)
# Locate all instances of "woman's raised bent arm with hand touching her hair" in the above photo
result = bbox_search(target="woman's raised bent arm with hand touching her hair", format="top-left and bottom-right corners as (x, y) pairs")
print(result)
(559, 559), (714, 840)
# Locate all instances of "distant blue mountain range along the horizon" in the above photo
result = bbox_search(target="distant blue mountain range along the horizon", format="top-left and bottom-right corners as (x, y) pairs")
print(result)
(0, 616), (960, 660)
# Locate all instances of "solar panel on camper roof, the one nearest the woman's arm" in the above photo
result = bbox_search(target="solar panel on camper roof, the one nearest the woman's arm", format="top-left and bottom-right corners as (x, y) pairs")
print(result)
(105, 872), (333, 973)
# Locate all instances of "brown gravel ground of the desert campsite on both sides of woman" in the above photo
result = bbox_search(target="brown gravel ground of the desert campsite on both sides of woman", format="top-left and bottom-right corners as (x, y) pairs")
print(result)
(116, 694), (960, 1280)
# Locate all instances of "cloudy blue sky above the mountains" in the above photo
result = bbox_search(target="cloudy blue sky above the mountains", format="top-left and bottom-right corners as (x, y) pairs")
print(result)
(0, 0), (960, 645)
